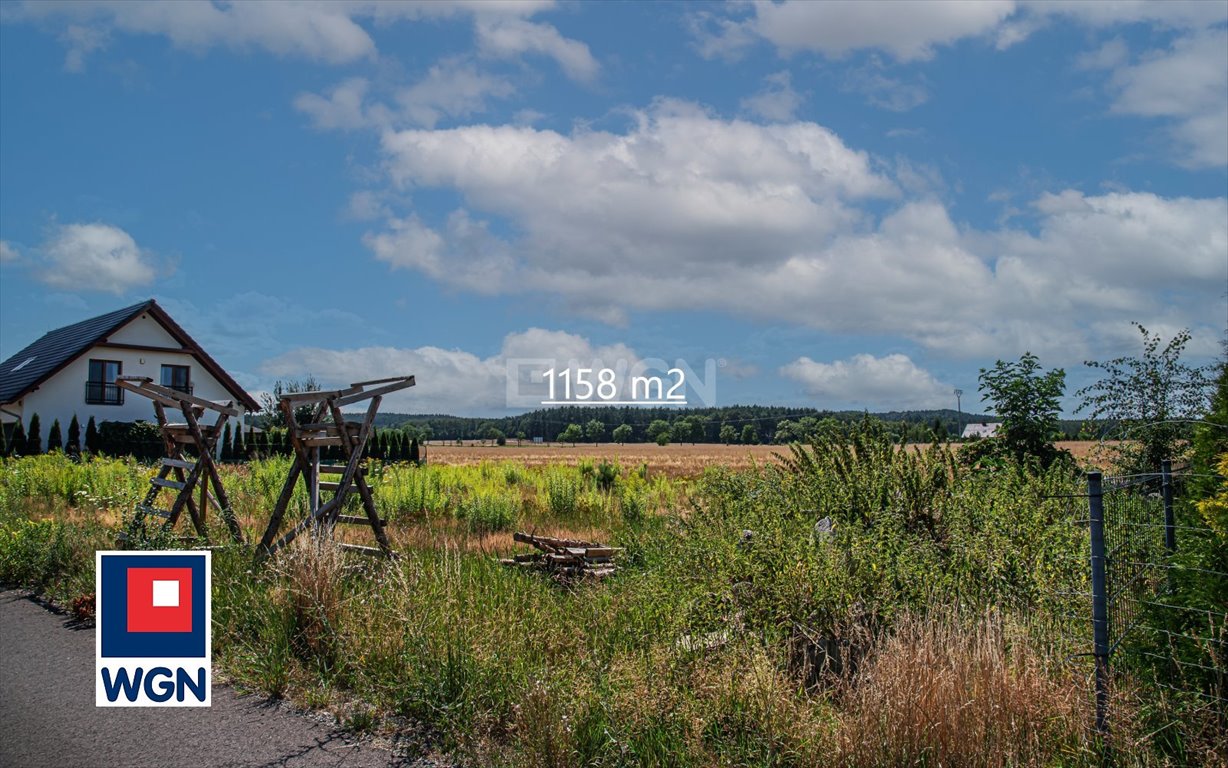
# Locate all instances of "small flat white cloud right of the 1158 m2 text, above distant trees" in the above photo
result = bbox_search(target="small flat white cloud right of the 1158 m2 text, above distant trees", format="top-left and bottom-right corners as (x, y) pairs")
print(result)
(780, 354), (952, 409)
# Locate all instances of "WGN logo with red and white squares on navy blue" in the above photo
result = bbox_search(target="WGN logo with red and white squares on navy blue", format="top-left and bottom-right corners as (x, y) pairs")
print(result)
(95, 552), (212, 707)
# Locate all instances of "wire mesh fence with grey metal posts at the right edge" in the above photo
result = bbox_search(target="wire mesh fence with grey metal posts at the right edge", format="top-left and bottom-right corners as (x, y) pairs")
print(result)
(1078, 462), (1228, 734)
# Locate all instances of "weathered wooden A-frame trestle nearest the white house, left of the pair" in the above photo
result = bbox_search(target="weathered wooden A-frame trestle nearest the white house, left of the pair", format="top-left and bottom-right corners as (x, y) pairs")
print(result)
(115, 376), (243, 543)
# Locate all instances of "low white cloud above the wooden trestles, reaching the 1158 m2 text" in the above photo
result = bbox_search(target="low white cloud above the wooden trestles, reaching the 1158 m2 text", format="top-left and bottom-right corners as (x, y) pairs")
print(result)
(260, 328), (639, 414)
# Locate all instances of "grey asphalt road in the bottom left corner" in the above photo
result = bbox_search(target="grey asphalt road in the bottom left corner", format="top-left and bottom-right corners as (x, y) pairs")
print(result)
(0, 591), (406, 768)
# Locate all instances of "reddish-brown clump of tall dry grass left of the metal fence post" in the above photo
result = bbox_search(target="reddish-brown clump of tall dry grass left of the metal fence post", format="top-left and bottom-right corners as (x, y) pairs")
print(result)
(839, 618), (1092, 768)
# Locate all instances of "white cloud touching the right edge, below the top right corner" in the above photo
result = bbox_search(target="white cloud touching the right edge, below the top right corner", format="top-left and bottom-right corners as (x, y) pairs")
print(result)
(1110, 29), (1228, 167)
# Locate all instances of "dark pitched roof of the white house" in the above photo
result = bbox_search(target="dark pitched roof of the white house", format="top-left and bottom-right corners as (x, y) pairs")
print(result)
(0, 299), (260, 410)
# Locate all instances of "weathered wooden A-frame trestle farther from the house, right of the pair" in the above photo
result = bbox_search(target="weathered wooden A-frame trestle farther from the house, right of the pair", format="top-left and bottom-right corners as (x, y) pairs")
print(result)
(257, 376), (414, 558)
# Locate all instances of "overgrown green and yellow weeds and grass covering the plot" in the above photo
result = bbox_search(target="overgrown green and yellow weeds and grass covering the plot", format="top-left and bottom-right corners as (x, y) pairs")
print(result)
(0, 432), (1228, 766)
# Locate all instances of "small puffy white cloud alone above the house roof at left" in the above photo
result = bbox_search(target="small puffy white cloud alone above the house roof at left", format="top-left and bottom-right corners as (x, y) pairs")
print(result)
(36, 224), (157, 294)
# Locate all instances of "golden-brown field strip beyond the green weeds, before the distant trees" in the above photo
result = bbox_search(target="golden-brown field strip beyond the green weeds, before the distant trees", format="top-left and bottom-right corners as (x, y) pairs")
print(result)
(425, 440), (1102, 477)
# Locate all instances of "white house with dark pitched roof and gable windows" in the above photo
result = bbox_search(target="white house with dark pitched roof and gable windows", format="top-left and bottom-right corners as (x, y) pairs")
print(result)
(0, 299), (259, 435)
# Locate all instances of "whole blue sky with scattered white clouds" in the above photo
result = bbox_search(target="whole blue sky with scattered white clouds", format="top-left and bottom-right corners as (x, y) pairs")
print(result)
(0, 0), (1228, 414)
